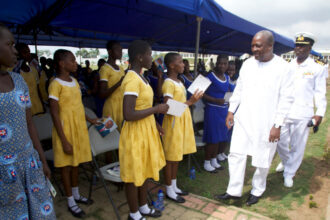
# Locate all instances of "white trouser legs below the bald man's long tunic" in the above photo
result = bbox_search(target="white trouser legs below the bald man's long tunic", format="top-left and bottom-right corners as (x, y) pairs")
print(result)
(227, 153), (269, 197)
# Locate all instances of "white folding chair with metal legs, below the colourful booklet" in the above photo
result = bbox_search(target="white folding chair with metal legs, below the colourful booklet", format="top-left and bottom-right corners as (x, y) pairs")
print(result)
(88, 125), (122, 219)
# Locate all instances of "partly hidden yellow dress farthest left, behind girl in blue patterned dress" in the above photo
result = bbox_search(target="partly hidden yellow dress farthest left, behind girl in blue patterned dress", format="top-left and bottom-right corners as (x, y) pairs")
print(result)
(21, 66), (44, 115)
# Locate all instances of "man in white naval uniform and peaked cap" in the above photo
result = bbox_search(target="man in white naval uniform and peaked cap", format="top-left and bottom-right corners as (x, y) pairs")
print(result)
(276, 32), (328, 187)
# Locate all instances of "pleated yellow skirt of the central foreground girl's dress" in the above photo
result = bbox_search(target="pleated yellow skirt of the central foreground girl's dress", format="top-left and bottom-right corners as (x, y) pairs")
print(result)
(119, 115), (165, 187)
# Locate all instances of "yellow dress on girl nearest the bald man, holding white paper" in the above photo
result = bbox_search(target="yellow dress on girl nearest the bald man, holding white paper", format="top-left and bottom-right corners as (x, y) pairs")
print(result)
(162, 78), (196, 161)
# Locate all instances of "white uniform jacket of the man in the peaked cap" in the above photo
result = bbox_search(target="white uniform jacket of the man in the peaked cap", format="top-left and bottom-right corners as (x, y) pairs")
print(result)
(288, 57), (328, 119)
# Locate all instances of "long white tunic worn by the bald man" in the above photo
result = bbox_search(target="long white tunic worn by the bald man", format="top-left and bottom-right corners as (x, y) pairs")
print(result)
(228, 55), (293, 167)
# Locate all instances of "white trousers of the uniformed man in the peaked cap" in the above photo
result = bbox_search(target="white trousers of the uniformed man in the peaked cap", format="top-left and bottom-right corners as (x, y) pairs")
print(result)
(277, 119), (310, 178)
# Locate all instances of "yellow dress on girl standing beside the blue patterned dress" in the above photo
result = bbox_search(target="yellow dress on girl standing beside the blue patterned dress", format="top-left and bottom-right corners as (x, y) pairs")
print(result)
(48, 77), (92, 167)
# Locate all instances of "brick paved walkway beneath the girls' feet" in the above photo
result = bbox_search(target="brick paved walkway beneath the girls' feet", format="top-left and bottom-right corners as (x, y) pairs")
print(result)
(55, 177), (269, 220)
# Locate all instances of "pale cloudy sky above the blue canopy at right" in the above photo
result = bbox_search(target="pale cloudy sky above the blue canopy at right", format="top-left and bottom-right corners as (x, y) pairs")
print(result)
(215, 0), (330, 50)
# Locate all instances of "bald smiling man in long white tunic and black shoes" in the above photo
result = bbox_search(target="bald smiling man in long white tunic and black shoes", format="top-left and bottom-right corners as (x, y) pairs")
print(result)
(216, 31), (293, 205)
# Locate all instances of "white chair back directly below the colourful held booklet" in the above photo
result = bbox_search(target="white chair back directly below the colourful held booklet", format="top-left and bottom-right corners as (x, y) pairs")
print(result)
(88, 125), (120, 156)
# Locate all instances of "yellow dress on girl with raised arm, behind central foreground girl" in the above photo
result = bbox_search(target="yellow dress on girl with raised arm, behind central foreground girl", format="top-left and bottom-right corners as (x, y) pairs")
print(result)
(100, 63), (125, 131)
